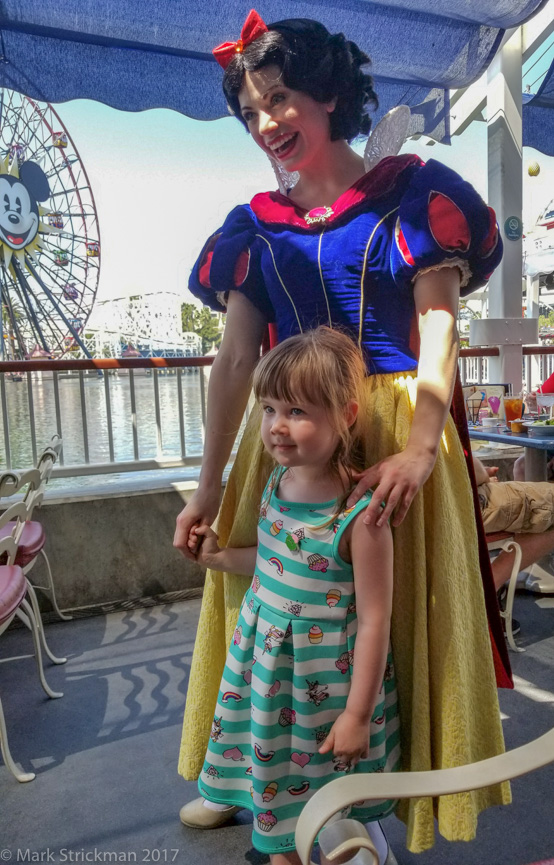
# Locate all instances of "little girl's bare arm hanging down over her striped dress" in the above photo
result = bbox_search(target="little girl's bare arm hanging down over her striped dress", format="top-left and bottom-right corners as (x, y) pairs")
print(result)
(319, 514), (393, 762)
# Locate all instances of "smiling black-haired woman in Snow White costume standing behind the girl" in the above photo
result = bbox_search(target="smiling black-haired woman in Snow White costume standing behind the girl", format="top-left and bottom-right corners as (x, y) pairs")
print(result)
(174, 12), (511, 851)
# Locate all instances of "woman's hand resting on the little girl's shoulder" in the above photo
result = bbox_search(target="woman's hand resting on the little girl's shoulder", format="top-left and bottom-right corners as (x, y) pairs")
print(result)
(347, 446), (435, 526)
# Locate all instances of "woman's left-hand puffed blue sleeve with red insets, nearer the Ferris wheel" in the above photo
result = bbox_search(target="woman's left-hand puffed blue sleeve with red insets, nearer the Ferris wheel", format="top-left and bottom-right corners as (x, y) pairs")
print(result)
(189, 205), (274, 321)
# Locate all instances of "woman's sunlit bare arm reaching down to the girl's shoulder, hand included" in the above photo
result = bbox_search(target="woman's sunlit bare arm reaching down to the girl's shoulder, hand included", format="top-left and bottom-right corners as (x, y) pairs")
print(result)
(348, 267), (460, 526)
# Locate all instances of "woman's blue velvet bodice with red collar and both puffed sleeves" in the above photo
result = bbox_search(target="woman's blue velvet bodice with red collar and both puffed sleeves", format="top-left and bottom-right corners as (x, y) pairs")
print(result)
(189, 155), (502, 374)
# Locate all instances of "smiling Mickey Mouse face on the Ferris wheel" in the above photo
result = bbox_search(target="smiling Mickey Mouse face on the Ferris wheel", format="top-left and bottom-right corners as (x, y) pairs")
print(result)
(0, 162), (50, 250)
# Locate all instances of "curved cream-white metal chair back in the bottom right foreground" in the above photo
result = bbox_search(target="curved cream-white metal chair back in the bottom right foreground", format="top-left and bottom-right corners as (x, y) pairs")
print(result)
(295, 729), (554, 865)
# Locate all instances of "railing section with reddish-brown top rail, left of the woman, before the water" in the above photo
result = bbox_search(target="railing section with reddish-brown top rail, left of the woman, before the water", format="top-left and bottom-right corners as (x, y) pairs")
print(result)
(0, 357), (213, 477)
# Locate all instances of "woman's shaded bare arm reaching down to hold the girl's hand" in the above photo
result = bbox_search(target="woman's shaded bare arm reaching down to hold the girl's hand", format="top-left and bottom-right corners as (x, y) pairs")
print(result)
(173, 291), (267, 559)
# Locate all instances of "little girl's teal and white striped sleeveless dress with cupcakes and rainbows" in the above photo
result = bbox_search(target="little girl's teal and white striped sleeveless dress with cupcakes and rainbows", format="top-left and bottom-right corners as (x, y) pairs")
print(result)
(198, 469), (400, 853)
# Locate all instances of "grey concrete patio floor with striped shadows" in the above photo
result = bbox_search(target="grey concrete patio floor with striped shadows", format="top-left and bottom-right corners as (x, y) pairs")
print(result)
(0, 593), (554, 865)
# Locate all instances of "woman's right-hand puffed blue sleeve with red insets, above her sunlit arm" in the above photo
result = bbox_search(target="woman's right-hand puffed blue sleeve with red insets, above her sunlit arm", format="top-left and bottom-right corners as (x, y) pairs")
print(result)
(391, 159), (502, 296)
